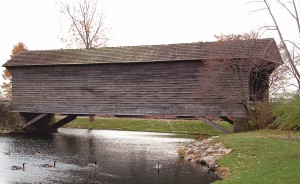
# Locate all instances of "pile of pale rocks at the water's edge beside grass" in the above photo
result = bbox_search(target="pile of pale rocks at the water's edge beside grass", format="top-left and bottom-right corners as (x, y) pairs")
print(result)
(179, 137), (232, 171)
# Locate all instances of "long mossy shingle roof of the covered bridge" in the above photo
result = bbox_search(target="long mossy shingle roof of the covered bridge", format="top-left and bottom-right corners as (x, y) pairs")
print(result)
(3, 39), (282, 67)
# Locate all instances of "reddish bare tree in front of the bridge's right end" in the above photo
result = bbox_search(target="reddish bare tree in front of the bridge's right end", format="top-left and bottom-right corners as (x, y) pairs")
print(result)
(212, 31), (285, 128)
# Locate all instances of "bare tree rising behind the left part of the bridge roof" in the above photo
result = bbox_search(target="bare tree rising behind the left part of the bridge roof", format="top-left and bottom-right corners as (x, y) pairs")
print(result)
(61, 0), (108, 49)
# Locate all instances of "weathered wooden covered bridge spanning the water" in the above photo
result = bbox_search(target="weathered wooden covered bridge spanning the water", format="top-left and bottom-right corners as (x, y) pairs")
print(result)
(3, 39), (282, 132)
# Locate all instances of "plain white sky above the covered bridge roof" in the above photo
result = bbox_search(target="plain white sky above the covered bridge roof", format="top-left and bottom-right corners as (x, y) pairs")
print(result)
(0, 0), (296, 83)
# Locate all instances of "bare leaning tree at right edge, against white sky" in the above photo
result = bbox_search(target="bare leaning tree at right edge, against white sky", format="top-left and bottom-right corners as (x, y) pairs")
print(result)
(255, 0), (300, 91)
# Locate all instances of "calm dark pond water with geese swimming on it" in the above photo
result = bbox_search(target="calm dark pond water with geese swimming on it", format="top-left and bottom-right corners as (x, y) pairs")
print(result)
(0, 129), (217, 184)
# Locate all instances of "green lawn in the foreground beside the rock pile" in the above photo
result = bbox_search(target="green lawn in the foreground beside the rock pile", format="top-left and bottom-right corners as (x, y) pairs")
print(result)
(214, 130), (300, 184)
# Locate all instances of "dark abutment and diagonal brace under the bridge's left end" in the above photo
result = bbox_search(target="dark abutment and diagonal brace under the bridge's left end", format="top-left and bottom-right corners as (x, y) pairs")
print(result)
(20, 112), (55, 134)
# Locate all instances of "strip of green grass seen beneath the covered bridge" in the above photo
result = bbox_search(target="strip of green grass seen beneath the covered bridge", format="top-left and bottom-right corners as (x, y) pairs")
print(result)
(56, 117), (232, 135)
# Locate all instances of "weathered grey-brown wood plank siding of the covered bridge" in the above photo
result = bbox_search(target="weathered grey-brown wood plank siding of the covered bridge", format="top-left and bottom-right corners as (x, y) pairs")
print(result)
(9, 60), (249, 116)
